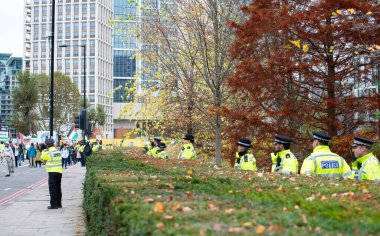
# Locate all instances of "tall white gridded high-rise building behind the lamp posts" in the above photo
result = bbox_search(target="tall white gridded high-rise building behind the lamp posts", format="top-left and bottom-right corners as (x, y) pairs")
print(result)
(24, 0), (114, 138)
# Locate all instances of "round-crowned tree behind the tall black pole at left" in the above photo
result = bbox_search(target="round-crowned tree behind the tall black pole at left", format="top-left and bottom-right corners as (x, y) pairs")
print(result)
(37, 72), (80, 132)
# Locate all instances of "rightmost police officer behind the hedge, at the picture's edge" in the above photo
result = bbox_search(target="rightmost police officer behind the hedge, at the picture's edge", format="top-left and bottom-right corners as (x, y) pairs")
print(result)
(350, 137), (380, 182)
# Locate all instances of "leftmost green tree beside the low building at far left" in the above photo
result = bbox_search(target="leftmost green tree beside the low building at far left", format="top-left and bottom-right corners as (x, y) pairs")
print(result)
(11, 71), (38, 134)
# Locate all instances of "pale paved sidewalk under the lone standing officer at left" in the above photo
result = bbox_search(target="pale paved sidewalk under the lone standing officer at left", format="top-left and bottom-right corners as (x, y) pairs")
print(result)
(0, 163), (86, 236)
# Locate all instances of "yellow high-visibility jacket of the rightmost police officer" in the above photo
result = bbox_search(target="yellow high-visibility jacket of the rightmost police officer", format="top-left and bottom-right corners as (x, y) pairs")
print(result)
(350, 153), (380, 182)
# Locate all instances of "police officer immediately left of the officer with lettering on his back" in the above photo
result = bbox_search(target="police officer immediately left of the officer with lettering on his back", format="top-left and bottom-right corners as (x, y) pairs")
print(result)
(271, 135), (298, 174)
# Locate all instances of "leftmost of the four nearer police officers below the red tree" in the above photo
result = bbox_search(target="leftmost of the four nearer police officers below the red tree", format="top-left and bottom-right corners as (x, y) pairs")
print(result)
(234, 138), (257, 171)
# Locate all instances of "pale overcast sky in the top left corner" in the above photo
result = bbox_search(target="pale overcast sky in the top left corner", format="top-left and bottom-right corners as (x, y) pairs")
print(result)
(0, 0), (24, 57)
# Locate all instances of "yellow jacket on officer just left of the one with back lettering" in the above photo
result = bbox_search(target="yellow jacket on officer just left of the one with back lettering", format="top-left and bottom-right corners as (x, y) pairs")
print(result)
(271, 150), (298, 174)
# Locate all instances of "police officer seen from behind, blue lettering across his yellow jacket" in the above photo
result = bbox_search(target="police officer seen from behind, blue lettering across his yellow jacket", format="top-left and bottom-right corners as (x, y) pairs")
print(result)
(301, 132), (352, 179)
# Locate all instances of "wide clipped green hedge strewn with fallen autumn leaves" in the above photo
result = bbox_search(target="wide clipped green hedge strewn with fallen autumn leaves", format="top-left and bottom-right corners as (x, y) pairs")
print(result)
(84, 150), (380, 235)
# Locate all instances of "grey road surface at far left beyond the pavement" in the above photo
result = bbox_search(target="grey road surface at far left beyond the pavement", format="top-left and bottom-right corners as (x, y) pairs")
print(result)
(0, 162), (47, 207)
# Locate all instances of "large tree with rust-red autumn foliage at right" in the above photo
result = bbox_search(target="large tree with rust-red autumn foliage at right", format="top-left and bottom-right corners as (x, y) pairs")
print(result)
(228, 0), (380, 157)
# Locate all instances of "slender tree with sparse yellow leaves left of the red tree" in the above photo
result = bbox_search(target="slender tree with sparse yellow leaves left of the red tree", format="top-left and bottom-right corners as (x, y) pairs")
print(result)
(143, 0), (246, 166)
